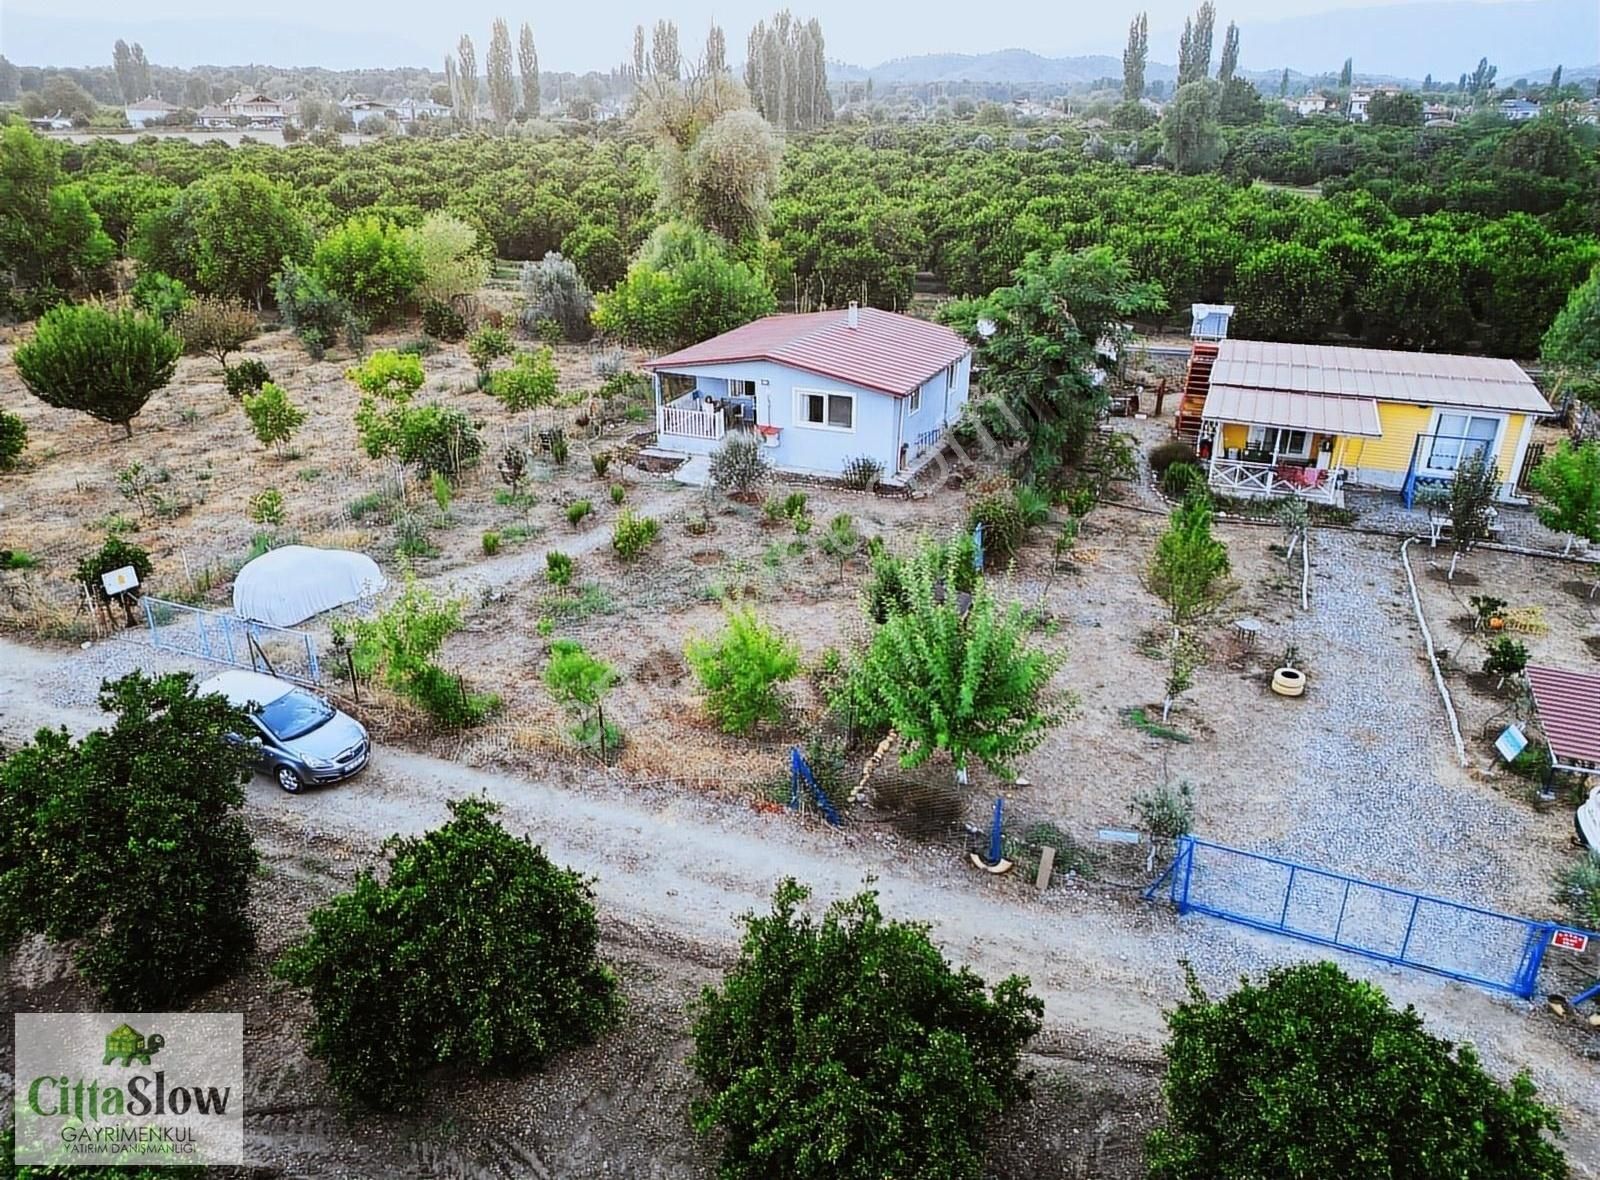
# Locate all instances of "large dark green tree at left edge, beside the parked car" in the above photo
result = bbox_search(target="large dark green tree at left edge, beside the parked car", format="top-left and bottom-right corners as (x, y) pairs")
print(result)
(0, 671), (258, 1004)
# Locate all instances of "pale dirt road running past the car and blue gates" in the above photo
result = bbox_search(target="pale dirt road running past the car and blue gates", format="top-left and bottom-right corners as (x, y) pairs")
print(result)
(0, 641), (1600, 1177)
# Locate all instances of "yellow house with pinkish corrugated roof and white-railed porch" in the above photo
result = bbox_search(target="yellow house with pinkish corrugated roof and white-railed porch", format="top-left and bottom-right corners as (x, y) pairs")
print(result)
(1178, 341), (1552, 507)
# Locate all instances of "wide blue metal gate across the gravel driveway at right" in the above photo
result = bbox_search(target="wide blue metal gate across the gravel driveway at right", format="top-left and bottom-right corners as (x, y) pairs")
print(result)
(1144, 836), (1587, 999)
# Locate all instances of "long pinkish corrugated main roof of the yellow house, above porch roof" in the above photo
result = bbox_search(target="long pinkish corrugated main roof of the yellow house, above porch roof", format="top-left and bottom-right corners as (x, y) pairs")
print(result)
(1211, 341), (1550, 414)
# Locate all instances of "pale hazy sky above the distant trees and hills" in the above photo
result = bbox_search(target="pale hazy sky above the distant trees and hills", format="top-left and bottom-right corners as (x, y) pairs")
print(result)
(0, 0), (1574, 70)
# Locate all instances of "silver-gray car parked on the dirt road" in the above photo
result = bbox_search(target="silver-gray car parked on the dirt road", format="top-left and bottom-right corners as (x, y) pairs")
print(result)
(200, 672), (371, 795)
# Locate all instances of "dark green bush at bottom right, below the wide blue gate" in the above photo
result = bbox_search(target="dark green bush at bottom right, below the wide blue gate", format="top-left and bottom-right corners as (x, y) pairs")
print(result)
(1146, 963), (1568, 1180)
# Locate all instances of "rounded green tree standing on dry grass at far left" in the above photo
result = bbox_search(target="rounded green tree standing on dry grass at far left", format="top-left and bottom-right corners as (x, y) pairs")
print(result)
(13, 304), (184, 438)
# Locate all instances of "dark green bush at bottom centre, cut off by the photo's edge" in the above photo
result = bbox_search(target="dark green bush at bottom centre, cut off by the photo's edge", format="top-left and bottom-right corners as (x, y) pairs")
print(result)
(690, 879), (1045, 1180)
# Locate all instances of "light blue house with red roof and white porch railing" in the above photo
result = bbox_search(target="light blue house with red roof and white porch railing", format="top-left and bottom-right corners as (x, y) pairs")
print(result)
(645, 304), (973, 475)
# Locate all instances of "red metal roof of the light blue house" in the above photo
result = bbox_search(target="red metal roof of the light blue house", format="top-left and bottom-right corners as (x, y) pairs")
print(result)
(645, 307), (968, 397)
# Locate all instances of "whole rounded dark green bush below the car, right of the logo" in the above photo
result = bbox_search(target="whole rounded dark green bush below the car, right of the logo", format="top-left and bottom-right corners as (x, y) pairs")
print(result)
(274, 799), (622, 1111)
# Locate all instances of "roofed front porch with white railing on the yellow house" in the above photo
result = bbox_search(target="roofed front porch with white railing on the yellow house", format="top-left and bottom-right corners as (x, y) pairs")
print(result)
(1198, 385), (1382, 508)
